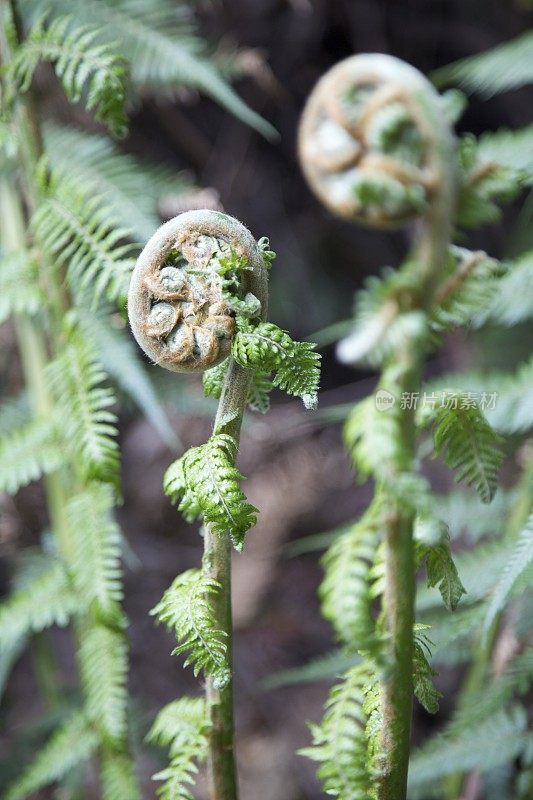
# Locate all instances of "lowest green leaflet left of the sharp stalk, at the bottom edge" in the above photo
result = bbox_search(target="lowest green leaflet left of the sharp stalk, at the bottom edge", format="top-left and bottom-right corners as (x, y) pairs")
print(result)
(146, 697), (209, 800)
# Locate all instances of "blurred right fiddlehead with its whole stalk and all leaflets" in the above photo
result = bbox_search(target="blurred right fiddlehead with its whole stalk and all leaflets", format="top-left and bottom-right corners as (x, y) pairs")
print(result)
(300, 55), (512, 800)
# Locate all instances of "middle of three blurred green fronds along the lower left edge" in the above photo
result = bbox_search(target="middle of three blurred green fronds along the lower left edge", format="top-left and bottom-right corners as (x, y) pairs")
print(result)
(0, 559), (79, 649)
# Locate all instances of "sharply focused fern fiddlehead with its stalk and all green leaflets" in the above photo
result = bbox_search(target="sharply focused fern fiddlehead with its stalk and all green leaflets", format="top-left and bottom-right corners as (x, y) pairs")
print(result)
(128, 211), (320, 800)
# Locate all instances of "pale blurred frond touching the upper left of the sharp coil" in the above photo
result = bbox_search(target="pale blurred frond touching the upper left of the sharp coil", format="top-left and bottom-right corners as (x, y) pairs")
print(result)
(44, 123), (192, 242)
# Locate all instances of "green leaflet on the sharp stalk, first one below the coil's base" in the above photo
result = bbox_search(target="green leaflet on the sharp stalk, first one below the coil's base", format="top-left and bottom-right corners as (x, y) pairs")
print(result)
(164, 433), (257, 550)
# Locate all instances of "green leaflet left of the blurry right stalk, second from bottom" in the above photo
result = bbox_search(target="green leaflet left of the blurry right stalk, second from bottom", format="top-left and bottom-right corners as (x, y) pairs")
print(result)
(320, 509), (380, 651)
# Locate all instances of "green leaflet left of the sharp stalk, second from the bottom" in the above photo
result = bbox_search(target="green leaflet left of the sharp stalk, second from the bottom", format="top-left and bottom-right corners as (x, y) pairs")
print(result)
(150, 569), (231, 689)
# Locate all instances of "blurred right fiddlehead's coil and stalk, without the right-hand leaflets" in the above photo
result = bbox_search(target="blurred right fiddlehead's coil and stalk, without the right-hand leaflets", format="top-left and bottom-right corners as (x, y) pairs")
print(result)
(299, 55), (455, 800)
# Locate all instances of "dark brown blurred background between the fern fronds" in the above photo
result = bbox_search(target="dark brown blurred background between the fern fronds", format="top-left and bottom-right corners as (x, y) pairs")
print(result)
(0, 0), (533, 800)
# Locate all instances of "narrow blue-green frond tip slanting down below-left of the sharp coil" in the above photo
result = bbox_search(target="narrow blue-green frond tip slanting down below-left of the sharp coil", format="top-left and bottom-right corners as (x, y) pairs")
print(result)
(81, 309), (178, 448)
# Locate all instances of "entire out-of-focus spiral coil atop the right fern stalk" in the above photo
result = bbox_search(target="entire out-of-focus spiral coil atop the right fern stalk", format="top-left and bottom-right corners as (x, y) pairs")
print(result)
(299, 54), (456, 227)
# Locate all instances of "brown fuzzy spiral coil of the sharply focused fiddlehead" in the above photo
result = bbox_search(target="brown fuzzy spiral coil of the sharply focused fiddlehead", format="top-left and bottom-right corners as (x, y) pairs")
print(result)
(128, 211), (267, 372)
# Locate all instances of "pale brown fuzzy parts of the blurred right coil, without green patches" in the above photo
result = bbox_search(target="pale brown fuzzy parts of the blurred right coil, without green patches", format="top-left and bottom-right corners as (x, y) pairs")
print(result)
(299, 55), (437, 228)
